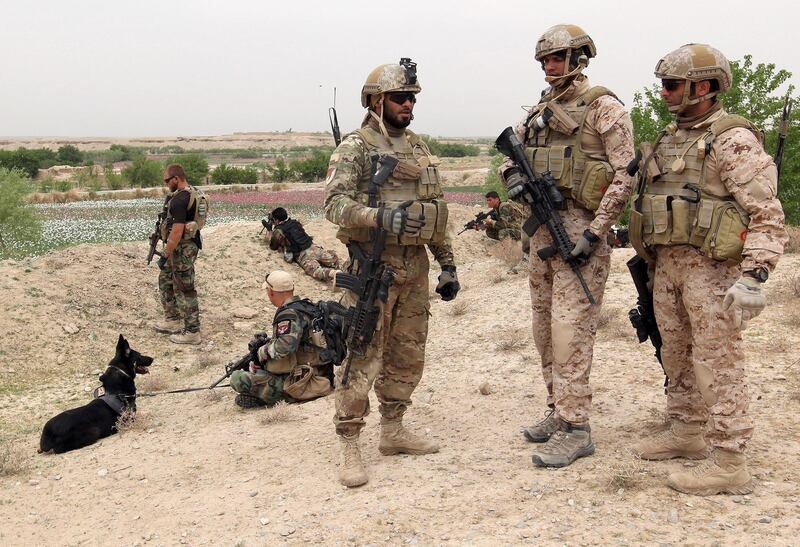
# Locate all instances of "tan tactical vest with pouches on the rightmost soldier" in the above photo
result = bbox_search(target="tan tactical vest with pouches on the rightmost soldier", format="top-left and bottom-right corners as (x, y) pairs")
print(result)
(630, 112), (763, 263)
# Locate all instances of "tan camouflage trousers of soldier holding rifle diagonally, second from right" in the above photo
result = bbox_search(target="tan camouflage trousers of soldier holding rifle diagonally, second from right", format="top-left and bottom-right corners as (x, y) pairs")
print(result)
(528, 209), (611, 424)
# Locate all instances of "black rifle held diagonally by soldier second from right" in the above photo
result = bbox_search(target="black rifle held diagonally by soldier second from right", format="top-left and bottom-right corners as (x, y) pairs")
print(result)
(494, 127), (596, 304)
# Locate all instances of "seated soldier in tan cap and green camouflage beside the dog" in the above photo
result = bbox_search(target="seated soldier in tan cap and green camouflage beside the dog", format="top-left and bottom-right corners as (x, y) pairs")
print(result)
(231, 270), (333, 408)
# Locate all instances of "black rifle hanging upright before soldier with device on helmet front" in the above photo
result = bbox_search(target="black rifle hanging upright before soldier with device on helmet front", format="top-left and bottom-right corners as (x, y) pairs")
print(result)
(336, 155), (400, 386)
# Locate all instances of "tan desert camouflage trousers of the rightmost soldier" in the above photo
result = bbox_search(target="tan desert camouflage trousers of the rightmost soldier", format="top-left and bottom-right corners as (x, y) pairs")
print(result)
(653, 245), (753, 452)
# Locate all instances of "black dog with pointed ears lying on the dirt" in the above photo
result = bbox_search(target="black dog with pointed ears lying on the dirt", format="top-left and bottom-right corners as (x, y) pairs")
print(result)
(39, 334), (153, 454)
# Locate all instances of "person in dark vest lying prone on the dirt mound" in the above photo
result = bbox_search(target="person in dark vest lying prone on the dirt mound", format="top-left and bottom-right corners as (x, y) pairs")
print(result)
(267, 207), (341, 281)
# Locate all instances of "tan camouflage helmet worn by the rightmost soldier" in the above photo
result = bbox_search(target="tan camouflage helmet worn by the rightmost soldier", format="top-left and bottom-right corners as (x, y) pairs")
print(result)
(655, 44), (733, 113)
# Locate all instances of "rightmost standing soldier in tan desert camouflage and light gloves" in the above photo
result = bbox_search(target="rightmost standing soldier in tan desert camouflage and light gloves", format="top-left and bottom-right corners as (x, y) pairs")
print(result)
(630, 44), (787, 495)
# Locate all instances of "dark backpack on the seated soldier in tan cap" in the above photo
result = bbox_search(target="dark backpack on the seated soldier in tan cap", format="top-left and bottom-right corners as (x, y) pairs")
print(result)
(286, 298), (347, 365)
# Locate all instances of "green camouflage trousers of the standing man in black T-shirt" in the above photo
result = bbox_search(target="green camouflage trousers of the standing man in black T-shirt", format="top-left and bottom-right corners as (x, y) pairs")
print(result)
(158, 240), (200, 332)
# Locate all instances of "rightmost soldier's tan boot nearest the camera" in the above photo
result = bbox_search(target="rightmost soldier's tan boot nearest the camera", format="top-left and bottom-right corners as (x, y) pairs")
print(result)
(667, 448), (753, 496)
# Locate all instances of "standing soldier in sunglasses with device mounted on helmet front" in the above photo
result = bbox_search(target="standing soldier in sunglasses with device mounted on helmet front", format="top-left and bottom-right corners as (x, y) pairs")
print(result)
(325, 58), (459, 487)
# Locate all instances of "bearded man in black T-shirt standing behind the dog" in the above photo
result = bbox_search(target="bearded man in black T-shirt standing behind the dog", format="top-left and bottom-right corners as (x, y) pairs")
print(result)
(154, 164), (205, 345)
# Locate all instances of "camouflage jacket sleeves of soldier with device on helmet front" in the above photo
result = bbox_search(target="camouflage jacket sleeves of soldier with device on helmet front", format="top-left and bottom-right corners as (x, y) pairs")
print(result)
(325, 124), (455, 266)
